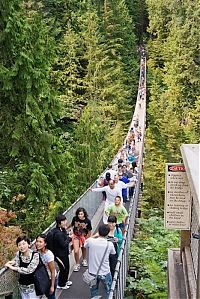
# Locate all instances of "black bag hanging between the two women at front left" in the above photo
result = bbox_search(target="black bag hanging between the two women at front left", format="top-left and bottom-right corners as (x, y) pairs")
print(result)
(33, 255), (51, 296)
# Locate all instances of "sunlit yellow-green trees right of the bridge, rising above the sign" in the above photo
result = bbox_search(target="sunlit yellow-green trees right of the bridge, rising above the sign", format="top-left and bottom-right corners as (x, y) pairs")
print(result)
(141, 0), (200, 209)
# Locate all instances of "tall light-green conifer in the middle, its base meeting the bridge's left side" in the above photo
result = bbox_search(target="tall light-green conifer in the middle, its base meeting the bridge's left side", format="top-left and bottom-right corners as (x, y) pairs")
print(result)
(75, 7), (125, 183)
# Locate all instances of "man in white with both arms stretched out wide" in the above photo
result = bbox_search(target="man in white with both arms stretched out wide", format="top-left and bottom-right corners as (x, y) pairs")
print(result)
(91, 180), (121, 224)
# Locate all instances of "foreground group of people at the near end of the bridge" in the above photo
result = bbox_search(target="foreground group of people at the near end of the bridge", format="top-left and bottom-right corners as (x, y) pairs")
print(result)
(5, 209), (127, 299)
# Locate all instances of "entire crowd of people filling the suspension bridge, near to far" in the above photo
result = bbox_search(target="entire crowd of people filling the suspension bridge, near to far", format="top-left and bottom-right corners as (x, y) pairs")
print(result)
(5, 51), (145, 299)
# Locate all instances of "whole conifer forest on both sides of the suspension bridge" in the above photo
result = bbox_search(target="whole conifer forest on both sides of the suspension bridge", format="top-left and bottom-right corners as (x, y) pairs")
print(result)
(0, 0), (200, 298)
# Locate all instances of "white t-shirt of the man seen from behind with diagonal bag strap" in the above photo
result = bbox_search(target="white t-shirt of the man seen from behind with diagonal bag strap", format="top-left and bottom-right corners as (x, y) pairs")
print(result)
(84, 237), (116, 275)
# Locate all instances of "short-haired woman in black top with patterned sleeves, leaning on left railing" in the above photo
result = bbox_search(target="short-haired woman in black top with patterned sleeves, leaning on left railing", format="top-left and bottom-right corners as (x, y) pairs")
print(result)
(5, 236), (40, 299)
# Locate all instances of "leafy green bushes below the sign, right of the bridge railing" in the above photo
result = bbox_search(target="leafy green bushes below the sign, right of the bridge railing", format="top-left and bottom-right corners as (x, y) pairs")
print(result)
(127, 214), (179, 299)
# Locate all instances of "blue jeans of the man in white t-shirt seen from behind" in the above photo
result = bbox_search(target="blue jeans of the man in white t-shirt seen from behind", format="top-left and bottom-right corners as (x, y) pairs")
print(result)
(90, 273), (112, 299)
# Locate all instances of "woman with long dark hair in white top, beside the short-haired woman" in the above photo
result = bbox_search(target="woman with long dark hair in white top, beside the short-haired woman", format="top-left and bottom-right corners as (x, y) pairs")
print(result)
(36, 234), (57, 299)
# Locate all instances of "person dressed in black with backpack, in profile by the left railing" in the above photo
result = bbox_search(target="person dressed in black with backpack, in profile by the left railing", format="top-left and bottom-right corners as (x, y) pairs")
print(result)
(47, 214), (72, 290)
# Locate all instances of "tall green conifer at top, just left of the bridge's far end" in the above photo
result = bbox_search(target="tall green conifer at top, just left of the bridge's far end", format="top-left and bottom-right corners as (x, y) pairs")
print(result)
(101, 0), (138, 108)
